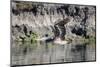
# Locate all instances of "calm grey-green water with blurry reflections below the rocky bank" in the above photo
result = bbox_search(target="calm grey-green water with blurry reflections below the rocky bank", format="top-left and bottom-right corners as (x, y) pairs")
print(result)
(11, 42), (95, 65)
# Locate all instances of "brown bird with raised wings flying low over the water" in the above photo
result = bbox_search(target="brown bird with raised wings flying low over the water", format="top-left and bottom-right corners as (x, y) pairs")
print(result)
(52, 17), (71, 44)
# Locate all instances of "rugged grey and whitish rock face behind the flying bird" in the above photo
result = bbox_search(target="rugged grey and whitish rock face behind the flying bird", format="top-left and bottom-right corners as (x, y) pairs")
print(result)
(11, 2), (96, 39)
